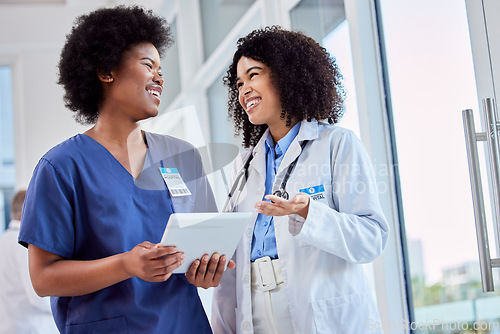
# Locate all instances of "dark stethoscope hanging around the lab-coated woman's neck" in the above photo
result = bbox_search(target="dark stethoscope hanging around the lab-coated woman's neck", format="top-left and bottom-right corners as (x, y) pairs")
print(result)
(222, 140), (307, 212)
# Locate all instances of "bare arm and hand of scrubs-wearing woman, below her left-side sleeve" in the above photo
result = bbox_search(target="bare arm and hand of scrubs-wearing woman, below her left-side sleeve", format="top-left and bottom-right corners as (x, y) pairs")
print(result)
(28, 242), (184, 296)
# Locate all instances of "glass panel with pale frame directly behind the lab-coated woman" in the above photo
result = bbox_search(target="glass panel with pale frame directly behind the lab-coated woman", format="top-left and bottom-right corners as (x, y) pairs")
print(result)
(289, 0), (408, 326)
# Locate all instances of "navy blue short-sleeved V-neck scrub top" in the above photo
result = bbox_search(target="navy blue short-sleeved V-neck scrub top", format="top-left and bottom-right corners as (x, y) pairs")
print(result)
(19, 133), (216, 334)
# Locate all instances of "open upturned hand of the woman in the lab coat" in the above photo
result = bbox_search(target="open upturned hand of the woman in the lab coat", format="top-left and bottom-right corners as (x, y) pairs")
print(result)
(255, 193), (310, 218)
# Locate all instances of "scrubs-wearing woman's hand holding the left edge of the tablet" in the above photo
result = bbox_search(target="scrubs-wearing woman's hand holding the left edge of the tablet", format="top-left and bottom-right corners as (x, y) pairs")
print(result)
(123, 241), (184, 282)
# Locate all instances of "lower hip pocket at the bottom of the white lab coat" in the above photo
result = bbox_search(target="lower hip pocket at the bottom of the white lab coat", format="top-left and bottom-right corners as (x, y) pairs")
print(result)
(311, 294), (383, 334)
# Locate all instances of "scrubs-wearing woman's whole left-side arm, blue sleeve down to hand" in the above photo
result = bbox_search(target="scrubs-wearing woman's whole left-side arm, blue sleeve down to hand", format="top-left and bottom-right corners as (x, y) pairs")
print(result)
(19, 151), (183, 296)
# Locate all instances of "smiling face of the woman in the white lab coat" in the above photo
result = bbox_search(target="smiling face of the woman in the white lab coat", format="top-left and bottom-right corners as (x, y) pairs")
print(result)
(236, 57), (285, 129)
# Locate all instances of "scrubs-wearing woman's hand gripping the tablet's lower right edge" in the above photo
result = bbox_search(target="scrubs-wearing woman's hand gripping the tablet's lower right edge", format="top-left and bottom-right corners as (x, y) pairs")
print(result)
(186, 253), (236, 289)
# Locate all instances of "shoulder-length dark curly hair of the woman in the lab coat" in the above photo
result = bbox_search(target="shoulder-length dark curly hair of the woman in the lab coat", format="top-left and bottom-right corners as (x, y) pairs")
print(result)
(223, 26), (345, 147)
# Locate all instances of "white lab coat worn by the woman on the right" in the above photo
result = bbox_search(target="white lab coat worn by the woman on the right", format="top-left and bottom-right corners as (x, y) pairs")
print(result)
(212, 120), (389, 334)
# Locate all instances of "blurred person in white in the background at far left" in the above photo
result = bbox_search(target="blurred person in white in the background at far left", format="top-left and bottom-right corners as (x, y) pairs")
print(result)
(0, 190), (58, 334)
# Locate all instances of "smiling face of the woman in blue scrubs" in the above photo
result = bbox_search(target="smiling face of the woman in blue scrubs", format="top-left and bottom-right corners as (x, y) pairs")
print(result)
(101, 43), (164, 122)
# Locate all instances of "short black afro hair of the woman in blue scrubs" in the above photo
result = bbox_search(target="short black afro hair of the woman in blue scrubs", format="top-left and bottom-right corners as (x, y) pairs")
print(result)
(58, 6), (173, 124)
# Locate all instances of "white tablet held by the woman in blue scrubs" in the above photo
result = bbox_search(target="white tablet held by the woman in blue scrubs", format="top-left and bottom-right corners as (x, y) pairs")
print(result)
(160, 212), (252, 274)
